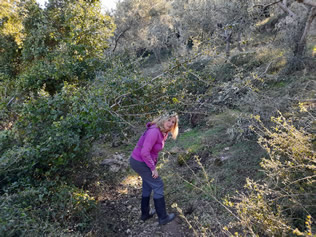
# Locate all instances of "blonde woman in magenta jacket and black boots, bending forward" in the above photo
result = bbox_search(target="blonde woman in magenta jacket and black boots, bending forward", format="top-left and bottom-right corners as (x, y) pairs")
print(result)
(130, 113), (179, 225)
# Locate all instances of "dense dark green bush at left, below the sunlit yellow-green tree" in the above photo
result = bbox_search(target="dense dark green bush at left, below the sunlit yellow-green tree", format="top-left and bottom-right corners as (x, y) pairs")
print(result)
(0, 83), (116, 187)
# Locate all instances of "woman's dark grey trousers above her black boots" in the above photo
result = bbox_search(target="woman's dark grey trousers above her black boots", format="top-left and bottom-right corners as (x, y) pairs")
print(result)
(130, 157), (164, 199)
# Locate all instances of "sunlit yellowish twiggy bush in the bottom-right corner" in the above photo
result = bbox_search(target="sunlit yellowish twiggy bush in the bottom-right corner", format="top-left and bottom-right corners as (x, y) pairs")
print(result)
(226, 115), (316, 236)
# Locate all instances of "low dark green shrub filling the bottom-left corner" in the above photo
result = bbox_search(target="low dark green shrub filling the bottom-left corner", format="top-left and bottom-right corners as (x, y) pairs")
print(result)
(0, 182), (96, 236)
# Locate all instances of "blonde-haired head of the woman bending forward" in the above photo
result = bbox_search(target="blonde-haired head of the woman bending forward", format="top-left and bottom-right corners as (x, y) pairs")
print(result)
(152, 112), (179, 139)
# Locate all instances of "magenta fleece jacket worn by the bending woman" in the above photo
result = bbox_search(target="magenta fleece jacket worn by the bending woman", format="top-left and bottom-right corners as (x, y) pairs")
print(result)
(132, 123), (168, 170)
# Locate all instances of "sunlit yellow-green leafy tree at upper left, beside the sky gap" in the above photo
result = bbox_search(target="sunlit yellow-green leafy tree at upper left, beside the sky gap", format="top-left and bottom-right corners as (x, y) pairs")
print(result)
(19, 0), (114, 95)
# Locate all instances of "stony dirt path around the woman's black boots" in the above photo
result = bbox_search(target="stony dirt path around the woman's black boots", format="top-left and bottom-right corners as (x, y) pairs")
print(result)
(97, 176), (193, 237)
